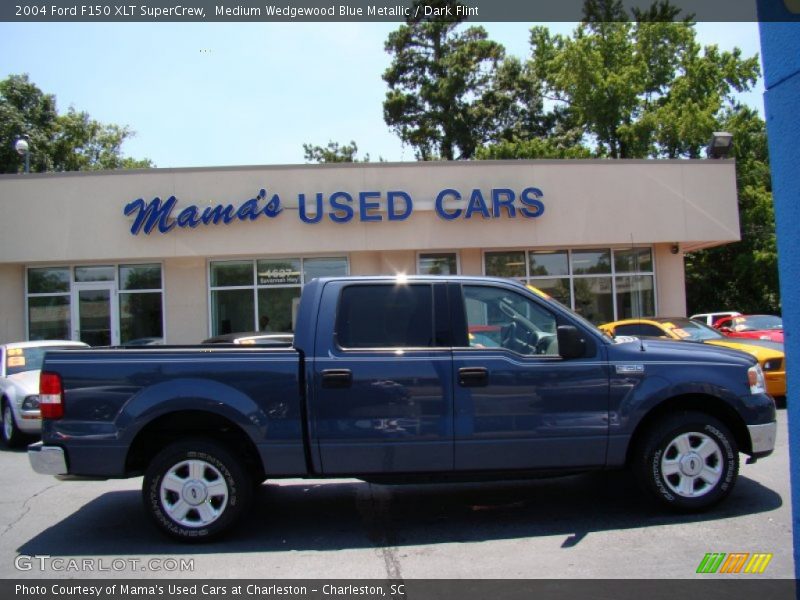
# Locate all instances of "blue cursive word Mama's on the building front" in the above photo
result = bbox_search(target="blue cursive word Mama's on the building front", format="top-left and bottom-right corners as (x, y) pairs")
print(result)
(124, 188), (283, 235)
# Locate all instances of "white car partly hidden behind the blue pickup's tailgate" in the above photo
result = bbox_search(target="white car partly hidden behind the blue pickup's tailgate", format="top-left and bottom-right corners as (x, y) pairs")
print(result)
(0, 340), (89, 447)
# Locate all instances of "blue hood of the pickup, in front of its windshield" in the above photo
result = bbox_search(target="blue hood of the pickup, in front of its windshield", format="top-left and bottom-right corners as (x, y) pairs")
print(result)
(610, 337), (756, 368)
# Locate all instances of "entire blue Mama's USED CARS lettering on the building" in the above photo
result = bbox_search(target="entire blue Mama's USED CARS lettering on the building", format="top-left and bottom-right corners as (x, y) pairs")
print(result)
(124, 187), (544, 235)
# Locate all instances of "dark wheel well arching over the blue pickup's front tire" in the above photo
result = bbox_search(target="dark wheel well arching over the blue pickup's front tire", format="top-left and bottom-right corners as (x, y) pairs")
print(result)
(626, 394), (751, 464)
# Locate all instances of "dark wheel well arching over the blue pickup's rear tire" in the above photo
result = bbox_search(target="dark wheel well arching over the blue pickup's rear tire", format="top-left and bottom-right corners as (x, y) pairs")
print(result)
(125, 410), (264, 479)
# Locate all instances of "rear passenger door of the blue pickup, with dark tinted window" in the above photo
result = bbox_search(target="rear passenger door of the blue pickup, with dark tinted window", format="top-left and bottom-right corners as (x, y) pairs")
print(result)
(309, 280), (453, 474)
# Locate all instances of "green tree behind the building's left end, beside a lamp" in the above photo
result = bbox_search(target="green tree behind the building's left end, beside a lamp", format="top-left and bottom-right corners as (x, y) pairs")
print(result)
(0, 75), (153, 173)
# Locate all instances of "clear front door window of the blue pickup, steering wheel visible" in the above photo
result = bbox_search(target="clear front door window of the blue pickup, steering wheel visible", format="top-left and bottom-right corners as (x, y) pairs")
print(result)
(463, 285), (558, 356)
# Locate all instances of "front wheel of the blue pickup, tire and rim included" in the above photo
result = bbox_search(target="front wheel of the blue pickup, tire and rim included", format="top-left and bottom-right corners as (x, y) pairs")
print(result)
(633, 412), (739, 512)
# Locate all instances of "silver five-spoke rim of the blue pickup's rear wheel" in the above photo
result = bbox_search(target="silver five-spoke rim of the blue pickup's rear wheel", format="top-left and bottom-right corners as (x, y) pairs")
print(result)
(160, 460), (229, 527)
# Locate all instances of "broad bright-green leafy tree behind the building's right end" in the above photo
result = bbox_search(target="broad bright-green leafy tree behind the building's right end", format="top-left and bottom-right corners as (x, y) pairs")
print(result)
(531, 0), (759, 158)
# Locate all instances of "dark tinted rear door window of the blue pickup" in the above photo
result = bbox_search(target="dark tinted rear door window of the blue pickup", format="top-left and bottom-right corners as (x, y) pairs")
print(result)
(336, 284), (434, 348)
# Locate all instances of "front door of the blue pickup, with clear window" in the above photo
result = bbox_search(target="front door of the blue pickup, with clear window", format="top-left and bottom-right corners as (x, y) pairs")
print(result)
(451, 283), (609, 471)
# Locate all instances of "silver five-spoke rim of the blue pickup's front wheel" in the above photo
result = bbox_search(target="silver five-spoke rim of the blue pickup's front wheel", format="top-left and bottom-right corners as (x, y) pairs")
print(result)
(661, 431), (724, 498)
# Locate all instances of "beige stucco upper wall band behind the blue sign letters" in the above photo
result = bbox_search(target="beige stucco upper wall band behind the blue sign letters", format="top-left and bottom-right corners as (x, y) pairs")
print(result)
(0, 160), (739, 263)
